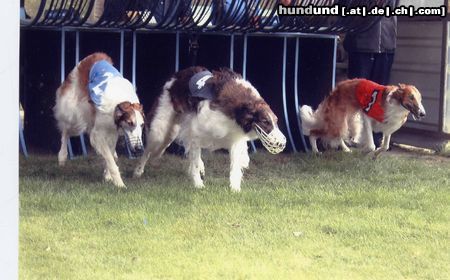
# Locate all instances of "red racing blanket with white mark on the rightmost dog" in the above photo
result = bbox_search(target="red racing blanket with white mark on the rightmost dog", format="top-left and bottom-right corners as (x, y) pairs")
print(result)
(356, 80), (386, 122)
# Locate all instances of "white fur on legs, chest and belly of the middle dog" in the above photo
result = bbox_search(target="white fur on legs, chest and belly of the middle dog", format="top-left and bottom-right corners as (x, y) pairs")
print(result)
(134, 79), (257, 192)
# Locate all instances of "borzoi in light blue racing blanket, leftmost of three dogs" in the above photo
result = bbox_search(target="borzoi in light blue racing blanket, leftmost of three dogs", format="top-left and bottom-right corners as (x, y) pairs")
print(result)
(53, 53), (144, 187)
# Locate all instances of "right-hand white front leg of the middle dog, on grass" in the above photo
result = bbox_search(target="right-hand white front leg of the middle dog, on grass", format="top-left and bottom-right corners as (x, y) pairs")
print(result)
(230, 141), (250, 192)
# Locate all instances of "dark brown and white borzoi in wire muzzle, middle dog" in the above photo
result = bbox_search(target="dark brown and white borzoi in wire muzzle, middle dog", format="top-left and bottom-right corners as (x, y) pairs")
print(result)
(134, 67), (286, 191)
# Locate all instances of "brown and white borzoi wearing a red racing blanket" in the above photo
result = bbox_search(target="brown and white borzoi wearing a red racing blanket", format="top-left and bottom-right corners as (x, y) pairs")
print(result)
(300, 79), (425, 156)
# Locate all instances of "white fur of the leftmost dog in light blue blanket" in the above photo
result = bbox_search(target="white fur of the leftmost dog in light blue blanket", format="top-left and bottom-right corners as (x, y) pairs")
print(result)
(53, 67), (144, 187)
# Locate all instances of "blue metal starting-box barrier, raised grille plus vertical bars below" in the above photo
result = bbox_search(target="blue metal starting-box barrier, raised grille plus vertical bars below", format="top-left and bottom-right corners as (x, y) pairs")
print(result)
(21, 0), (391, 155)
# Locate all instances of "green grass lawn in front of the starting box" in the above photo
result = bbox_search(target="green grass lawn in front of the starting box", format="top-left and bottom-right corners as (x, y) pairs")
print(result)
(19, 152), (450, 279)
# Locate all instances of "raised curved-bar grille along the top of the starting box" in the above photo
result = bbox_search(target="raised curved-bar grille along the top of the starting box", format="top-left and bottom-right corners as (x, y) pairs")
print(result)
(22, 0), (390, 34)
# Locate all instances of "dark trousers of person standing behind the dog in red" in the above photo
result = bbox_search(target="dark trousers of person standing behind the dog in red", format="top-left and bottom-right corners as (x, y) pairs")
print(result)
(347, 52), (394, 147)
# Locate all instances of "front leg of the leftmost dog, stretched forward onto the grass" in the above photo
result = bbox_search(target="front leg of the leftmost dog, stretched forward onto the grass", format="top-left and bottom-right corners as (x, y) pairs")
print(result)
(90, 128), (125, 188)
